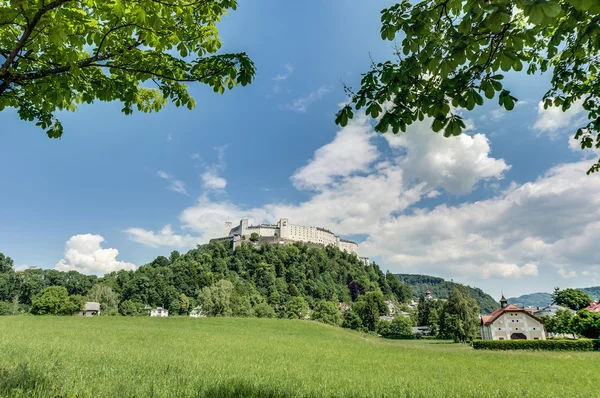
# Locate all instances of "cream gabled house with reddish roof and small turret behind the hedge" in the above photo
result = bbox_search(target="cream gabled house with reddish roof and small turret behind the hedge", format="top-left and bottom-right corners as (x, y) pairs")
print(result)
(480, 295), (546, 340)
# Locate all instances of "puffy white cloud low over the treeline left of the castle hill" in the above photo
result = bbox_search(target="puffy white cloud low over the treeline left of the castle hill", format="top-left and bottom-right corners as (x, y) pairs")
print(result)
(55, 234), (136, 275)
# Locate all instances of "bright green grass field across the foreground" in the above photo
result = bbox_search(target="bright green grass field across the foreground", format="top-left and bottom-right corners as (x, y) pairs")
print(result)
(0, 316), (600, 398)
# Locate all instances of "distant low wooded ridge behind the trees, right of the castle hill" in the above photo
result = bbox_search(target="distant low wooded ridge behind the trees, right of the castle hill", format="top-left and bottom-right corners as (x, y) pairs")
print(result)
(396, 274), (500, 313)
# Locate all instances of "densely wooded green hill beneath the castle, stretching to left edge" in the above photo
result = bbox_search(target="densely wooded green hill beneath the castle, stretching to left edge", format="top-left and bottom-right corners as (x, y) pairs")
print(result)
(0, 242), (411, 316)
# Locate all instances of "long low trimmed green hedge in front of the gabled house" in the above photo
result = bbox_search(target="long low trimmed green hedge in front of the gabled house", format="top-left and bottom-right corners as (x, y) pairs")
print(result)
(473, 339), (594, 351)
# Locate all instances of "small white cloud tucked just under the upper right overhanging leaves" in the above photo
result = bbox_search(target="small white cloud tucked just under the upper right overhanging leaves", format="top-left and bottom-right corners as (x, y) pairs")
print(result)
(533, 100), (586, 138)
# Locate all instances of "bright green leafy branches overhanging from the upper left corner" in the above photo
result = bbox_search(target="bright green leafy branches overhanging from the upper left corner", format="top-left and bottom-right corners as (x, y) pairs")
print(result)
(0, 0), (255, 138)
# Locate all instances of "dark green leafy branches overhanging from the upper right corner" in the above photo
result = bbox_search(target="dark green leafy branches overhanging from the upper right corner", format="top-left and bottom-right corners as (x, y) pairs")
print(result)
(336, 0), (600, 173)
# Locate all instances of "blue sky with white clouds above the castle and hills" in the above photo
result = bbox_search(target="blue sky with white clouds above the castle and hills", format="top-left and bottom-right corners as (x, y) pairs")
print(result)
(0, 0), (600, 298)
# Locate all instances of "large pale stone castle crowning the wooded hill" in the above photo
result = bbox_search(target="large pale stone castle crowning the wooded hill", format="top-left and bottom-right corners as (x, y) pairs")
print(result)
(213, 218), (369, 264)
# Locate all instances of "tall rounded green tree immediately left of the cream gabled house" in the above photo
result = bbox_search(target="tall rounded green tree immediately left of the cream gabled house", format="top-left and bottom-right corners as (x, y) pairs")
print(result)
(440, 285), (479, 343)
